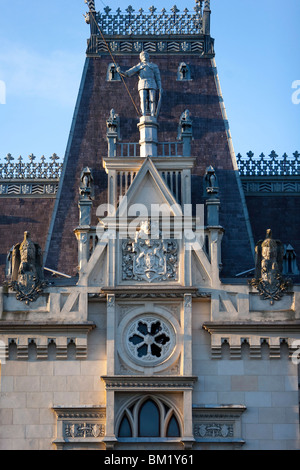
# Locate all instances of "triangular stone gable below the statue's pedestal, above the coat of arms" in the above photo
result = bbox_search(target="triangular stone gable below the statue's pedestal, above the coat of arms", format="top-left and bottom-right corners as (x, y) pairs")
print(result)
(116, 158), (182, 217)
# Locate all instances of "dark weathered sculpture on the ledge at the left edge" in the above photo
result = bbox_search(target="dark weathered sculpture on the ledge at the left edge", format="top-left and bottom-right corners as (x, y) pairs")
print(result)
(9, 232), (47, 304)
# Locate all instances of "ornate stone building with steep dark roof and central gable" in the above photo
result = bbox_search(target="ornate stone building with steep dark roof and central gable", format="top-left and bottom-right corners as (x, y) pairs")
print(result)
(0, 0), (300, 450)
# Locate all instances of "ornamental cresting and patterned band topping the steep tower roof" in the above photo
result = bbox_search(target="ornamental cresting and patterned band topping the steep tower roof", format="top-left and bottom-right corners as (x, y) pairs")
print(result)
(85, 4), (214, 57)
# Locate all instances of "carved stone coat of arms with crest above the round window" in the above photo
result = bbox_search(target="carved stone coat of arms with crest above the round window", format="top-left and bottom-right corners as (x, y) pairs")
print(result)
(122, 221), (178, 282)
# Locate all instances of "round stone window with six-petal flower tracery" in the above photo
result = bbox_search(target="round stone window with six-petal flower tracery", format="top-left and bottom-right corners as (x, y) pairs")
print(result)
(126, 316), (175, 366)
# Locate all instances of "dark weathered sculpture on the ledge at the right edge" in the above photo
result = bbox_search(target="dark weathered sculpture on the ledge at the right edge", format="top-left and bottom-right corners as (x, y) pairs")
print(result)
(250, 229), (292, 305)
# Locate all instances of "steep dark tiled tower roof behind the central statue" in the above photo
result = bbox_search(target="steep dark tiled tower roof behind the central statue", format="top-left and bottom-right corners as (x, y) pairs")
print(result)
(47, 55), (253, 277)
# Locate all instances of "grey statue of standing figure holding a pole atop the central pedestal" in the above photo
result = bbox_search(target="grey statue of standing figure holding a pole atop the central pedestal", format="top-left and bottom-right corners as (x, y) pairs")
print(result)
(117, 51), (163, 117)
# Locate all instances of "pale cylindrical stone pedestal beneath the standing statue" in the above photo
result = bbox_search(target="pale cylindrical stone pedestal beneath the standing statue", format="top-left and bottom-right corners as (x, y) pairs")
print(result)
(138, 116), (158, 158)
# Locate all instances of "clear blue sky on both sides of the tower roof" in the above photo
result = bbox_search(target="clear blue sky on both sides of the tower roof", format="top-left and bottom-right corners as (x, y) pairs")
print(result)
(0, 0), (300, 160)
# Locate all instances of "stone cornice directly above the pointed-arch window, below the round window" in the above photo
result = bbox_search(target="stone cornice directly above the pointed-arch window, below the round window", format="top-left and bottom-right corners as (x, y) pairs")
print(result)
(101, 375), (198, 392)
